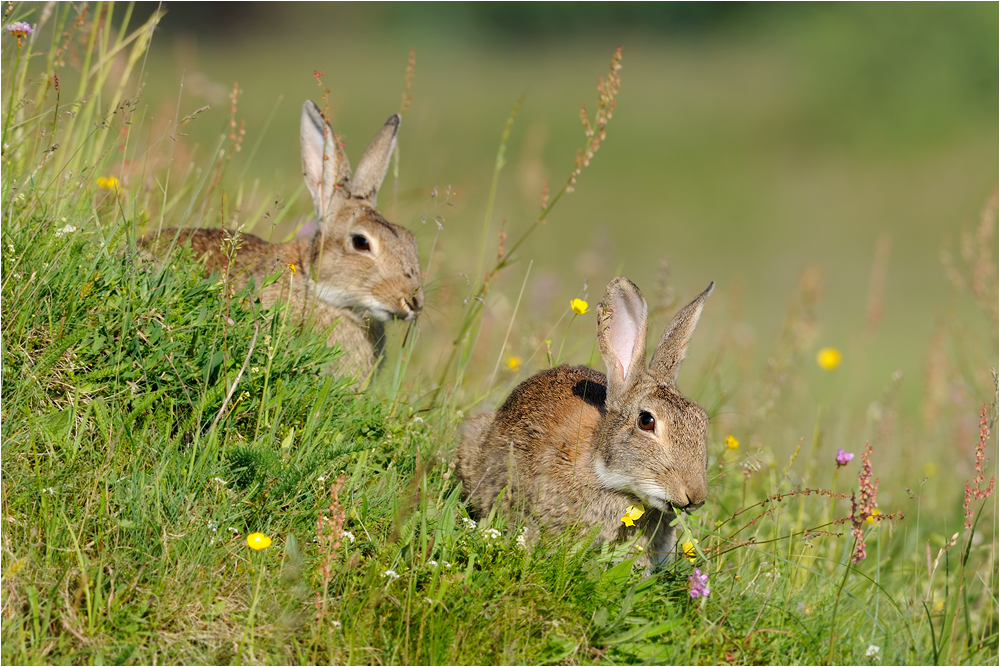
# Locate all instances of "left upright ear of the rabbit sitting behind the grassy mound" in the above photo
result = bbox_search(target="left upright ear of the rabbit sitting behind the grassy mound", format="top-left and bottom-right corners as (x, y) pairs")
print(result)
(299, 100), (351, 220)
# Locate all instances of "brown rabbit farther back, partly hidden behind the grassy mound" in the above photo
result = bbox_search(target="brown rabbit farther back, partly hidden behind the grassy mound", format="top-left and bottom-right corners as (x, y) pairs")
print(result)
(140, 101), (424, 379)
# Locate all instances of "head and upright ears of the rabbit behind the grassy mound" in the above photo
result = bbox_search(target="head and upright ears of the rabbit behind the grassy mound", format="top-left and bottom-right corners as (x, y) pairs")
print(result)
(300, 101), (424, 321)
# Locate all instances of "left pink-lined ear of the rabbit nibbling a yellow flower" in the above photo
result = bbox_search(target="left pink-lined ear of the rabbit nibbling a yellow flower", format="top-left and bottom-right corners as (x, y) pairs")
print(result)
(597, 278), (646, 405)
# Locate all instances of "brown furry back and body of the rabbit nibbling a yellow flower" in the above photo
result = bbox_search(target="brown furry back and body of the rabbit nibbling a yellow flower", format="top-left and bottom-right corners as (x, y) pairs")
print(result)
(457, 366), (607, 525)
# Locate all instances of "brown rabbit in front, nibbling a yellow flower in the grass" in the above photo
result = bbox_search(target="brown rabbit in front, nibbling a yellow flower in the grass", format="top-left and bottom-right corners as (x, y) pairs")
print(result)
(457, 278), (715, 567)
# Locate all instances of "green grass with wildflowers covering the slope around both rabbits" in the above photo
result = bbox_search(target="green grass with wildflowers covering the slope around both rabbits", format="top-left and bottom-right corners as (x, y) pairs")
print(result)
(0, 4), (998, 664)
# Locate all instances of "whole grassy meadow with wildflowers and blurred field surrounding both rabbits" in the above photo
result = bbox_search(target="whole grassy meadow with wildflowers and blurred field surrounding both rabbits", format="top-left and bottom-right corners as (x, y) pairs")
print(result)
(0, 3), (1000, 664)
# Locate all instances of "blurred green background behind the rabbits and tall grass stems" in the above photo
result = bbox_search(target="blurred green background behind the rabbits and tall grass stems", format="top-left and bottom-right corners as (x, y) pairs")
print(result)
(115, 2), (998, 412)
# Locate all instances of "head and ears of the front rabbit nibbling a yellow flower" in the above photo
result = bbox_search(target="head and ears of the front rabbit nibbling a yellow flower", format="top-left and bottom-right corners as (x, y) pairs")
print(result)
(594, 278), (715, 512)
